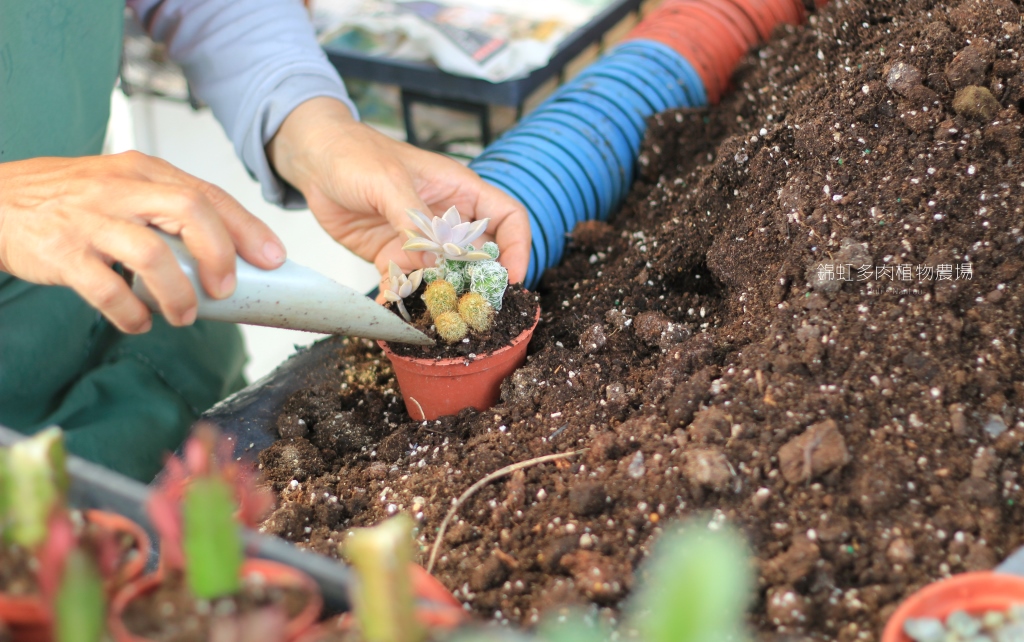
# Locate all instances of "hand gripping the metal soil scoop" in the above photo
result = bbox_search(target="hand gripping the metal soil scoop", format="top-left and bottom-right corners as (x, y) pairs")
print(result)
(0, 152), (285, 333)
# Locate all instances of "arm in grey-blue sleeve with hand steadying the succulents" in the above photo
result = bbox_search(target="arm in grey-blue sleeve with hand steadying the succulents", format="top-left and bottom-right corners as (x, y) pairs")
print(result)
(129, 0), (529, 281)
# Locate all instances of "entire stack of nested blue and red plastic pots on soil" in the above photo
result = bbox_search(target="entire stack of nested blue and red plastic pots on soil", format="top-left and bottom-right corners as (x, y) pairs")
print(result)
(470, 0), (824, 288)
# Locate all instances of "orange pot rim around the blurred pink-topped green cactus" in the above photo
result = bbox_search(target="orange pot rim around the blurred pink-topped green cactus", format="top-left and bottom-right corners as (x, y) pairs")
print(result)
(108, 559), (324, 642)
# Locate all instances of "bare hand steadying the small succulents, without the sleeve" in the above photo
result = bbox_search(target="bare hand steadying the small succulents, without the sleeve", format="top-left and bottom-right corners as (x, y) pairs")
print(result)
(267, 98), (530, 283)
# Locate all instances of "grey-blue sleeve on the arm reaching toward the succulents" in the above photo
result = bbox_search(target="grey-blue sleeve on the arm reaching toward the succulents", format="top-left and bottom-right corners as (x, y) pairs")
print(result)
(128, 0), (357, 207)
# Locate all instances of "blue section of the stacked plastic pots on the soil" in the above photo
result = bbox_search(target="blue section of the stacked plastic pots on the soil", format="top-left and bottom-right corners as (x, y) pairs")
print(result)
(470, 40), (708, 288)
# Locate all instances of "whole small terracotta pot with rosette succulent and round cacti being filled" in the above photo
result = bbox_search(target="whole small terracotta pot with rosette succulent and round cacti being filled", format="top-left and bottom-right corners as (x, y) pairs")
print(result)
(379, 207), (541, 420)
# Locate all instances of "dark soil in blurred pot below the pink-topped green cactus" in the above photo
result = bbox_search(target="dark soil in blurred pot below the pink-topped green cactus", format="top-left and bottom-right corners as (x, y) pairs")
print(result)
(123, 575), (308, 642)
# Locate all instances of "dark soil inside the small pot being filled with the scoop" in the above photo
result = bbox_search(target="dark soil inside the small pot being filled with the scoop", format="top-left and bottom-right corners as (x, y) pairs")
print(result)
(387, 284), (539, 359)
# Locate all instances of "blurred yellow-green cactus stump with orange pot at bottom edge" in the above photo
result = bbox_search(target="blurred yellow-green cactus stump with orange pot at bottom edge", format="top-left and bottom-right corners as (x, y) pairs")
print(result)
(294, 515), (468, 642)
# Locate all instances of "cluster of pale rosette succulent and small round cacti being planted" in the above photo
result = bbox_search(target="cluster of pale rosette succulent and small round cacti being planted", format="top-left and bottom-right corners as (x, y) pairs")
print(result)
(397, 207), (508, 343)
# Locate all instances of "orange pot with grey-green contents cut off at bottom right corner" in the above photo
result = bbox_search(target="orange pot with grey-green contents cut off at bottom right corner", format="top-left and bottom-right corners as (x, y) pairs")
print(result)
(882, 571), (1024, 642)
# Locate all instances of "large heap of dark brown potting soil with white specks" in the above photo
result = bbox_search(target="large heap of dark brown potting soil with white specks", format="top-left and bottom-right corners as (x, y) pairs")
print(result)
(264, 0), (1024, 642)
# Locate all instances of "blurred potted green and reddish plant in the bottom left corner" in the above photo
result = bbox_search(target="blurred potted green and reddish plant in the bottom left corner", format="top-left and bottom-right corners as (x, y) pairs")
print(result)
(0, 428), (150, 641)
